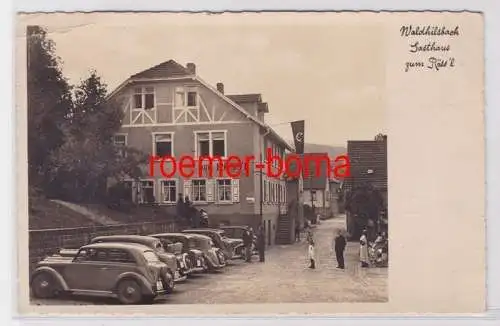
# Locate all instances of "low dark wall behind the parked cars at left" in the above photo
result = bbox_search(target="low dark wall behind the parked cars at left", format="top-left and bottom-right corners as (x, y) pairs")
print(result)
(29, 220), (178, 271)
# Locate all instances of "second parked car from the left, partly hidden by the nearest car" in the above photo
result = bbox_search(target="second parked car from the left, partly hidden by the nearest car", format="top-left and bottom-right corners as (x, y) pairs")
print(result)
(90, 235), (189, 292)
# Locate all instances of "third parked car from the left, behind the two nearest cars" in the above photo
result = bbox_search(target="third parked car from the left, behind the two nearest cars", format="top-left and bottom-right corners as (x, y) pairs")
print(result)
(151, 233), (226, 272)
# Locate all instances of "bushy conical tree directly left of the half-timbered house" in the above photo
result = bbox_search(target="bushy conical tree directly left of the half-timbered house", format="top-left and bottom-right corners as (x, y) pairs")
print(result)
(46, 71), (147, 201)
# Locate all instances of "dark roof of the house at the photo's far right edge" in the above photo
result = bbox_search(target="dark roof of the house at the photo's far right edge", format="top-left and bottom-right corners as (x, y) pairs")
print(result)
(343, 140), (387, 190)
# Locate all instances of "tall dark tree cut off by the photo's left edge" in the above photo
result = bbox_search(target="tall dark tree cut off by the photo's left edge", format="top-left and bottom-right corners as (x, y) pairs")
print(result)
(27, 26), (72, 189)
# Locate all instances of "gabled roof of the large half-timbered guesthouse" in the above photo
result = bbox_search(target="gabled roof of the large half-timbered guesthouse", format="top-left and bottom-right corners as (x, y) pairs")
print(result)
(106, 60), (294, 151)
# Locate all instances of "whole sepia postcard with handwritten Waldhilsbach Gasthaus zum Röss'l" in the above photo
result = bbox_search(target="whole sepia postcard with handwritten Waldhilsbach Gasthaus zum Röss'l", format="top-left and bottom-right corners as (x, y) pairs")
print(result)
(16, 12), (486, 316)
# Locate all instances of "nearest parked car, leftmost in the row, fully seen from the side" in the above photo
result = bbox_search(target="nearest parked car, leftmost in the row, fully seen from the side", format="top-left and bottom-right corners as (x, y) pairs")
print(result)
(30, 242), (172, 304)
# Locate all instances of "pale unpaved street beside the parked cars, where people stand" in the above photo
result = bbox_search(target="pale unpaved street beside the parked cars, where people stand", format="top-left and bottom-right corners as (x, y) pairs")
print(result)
(32, 218), (388, 305)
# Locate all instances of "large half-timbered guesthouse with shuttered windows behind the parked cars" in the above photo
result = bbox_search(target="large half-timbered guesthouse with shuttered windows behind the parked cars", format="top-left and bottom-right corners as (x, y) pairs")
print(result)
(109, 60), (293, 242)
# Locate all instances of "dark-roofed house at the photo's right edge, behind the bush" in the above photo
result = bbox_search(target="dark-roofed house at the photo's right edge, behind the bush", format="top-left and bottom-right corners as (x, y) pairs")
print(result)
(342, 136), (387, 236)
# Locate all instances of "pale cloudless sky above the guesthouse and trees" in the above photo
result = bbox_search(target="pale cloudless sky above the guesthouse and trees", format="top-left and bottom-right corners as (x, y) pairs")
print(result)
(31, 14), (385, 146)
